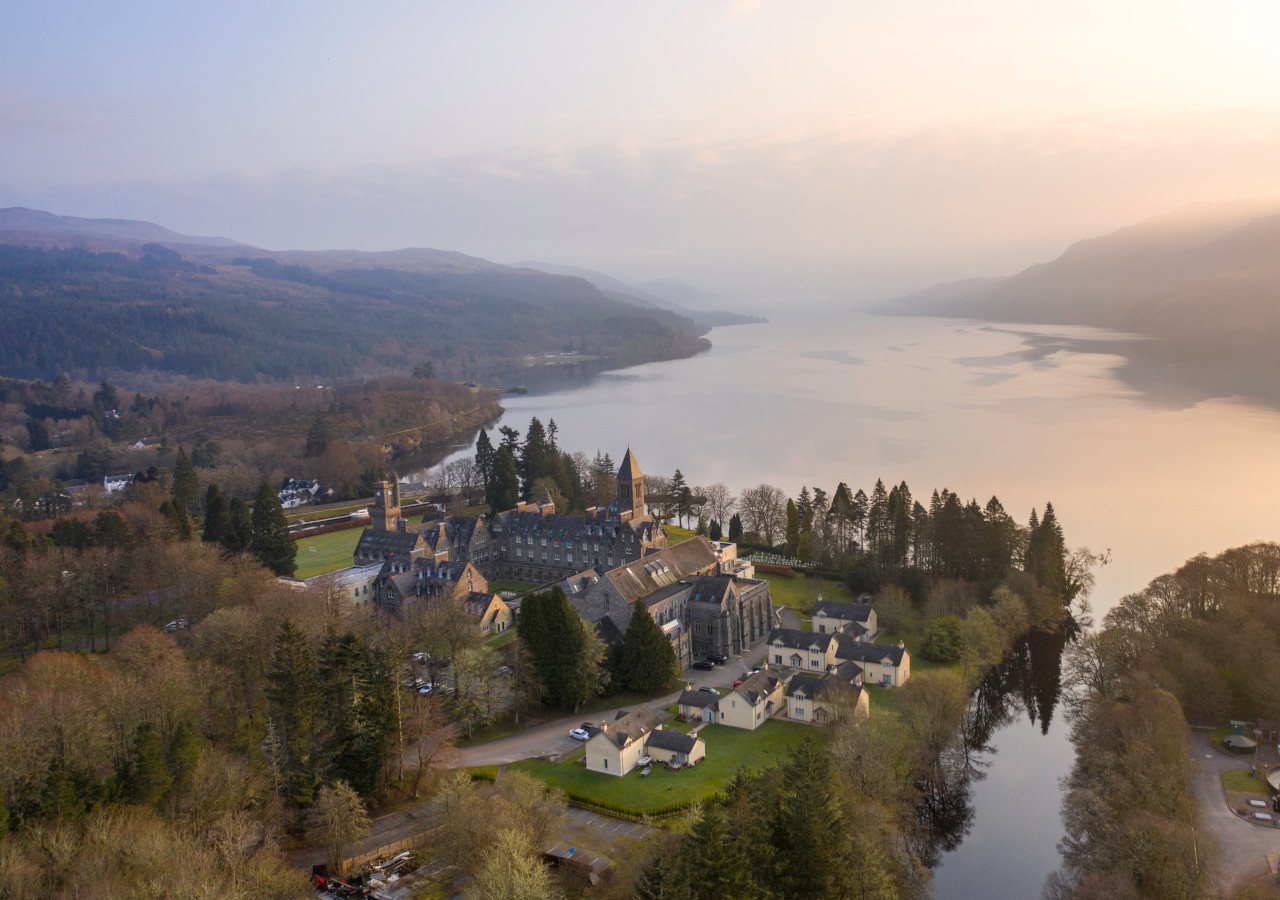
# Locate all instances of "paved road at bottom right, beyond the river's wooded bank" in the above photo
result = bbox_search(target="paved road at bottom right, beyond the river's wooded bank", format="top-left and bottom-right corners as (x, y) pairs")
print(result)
(1187, 732), (1280, 896)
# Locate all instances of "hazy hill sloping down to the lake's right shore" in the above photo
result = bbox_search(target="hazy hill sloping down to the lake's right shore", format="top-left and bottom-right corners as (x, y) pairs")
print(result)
(879, 204), (1280, 398)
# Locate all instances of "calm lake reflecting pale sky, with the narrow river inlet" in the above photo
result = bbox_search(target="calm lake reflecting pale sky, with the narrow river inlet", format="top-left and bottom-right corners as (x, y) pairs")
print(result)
(430, 305), (1280, 900)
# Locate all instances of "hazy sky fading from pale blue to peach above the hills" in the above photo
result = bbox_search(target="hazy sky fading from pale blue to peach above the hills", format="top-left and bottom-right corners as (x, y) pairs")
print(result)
(0, 0), (1280, 291)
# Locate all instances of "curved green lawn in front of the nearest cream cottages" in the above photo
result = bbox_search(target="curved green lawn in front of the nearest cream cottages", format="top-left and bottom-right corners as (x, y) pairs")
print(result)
(512, 719), (808, 813)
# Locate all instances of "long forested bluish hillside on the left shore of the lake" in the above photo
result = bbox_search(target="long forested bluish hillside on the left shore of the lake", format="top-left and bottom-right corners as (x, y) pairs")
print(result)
(0, 210), (709, 380)
